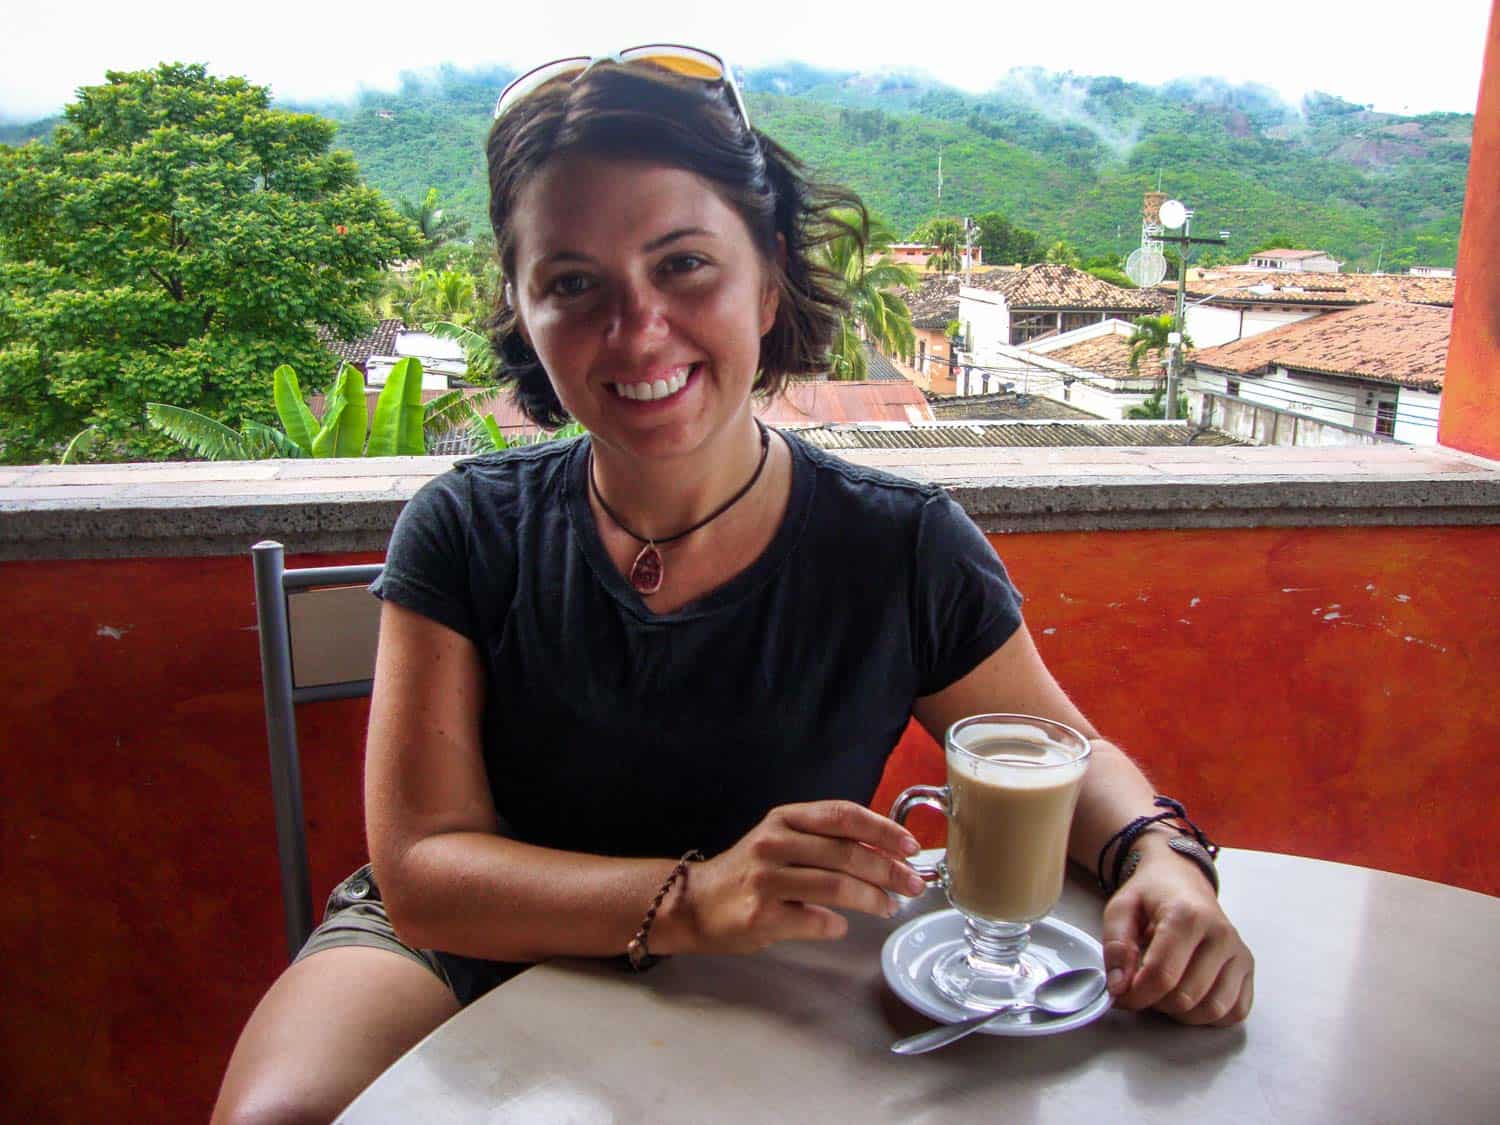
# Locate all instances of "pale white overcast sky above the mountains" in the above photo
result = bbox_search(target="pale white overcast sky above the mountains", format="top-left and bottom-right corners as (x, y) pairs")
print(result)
(0, 0), (1491, 120)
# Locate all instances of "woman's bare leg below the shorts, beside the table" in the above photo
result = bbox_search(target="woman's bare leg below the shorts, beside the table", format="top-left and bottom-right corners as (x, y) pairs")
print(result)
(213, 945), (459, 1125)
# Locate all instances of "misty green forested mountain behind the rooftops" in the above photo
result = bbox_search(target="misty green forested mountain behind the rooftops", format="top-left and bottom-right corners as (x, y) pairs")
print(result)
(5, 65), (1473, 270)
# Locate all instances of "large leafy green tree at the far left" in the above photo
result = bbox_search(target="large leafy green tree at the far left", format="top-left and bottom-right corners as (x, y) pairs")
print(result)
(0, 63), (419, 462)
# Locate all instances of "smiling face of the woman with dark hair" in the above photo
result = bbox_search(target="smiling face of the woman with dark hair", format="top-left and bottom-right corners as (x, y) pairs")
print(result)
(513, 158), (777, 458)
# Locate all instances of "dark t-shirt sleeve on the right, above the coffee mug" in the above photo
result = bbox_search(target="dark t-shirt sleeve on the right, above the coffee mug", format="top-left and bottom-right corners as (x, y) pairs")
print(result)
(912, 494), (1022, 696)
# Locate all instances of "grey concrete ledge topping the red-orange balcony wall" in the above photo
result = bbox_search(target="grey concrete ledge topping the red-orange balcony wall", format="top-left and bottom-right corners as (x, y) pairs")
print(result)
(0, 446), (1500, 561)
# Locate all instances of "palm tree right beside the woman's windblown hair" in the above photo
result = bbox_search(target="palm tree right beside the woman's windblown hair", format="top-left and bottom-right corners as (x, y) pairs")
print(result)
(819, 213), (918, 380)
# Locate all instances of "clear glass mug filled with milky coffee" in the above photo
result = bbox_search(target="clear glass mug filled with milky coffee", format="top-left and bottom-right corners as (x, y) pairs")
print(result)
(891, 714), (1089, 1011)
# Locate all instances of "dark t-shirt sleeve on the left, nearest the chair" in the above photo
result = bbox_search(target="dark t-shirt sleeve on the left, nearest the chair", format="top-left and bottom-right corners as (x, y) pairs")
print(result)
(371, 473), (479, 642)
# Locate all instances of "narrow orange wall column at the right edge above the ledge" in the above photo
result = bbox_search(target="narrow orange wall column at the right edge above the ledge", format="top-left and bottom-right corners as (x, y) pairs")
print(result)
(1437, 0), (1500, 458)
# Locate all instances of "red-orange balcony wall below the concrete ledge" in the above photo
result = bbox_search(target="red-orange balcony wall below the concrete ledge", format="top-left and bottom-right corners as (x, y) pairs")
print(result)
(0, 528), (1500, 1121)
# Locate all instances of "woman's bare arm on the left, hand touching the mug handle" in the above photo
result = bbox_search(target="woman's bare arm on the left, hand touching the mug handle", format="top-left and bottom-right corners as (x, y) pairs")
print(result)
(365, 603), (921, 962)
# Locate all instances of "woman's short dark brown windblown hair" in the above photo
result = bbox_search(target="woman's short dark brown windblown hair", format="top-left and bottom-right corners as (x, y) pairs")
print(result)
(486, 63), (869, 429)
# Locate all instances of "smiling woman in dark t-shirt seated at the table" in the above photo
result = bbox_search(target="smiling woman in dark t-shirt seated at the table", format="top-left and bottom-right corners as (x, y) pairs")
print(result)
(216, 48), (1253, 1121)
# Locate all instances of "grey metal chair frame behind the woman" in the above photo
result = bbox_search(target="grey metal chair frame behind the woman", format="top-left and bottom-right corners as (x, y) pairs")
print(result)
(251, 540), (383, 960)
